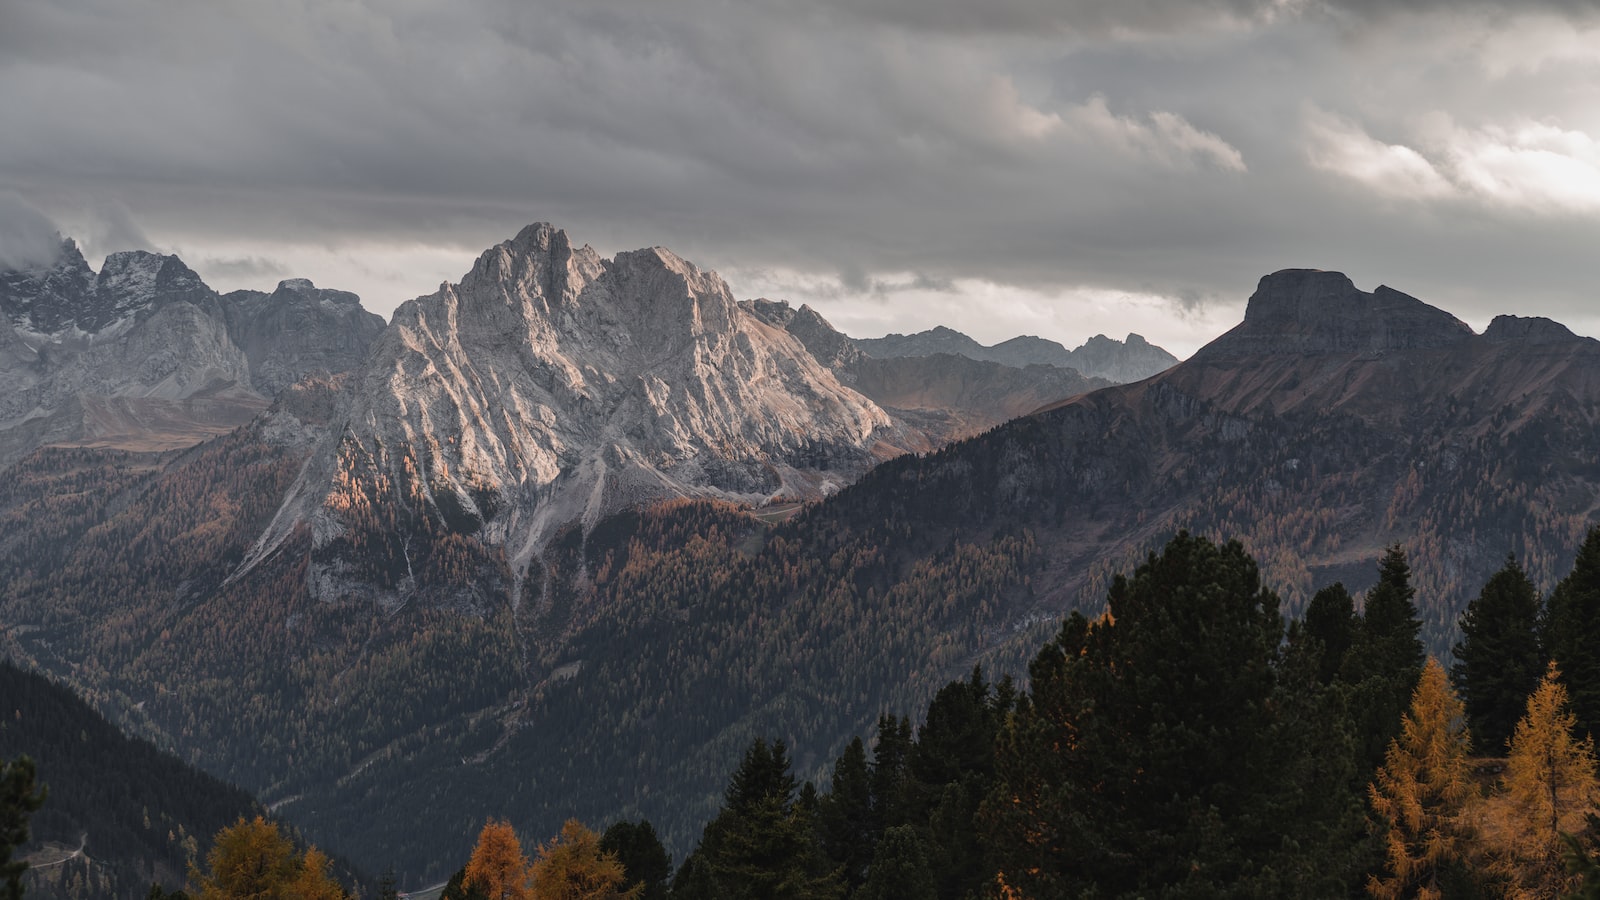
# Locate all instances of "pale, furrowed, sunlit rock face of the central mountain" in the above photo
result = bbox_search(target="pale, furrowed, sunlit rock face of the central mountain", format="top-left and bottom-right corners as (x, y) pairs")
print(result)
(254, 224), (902, 594)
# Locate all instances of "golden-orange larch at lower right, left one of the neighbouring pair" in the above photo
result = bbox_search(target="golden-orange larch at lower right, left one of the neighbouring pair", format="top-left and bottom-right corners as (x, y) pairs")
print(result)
(1366, 657), (1477, 900)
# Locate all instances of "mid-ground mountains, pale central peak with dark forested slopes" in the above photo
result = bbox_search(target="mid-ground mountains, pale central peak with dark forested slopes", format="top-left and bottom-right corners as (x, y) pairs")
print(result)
(0, 226), (1600, 876)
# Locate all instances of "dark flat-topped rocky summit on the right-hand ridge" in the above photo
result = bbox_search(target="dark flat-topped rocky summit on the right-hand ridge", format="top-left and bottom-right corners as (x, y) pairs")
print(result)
(1195, 269), (1472, 357)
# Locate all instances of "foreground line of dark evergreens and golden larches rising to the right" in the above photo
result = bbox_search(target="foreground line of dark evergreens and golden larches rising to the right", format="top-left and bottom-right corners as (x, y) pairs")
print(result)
(416, 528), (1600, 900)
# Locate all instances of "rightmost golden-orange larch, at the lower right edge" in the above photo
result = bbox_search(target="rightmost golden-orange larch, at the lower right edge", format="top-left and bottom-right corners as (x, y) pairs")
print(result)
(1506, 663), (1600, 897)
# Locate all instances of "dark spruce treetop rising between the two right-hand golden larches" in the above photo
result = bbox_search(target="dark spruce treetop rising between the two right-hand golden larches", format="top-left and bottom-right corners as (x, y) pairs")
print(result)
(1450, 556), (1546, 756)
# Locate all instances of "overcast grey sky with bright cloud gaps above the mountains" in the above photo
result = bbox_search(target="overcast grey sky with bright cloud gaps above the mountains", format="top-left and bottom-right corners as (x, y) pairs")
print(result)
(0, 0), (1600, 354)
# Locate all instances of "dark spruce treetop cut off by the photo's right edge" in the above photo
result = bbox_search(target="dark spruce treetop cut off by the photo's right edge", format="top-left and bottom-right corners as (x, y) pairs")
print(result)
(1544, 525), (1600, 735)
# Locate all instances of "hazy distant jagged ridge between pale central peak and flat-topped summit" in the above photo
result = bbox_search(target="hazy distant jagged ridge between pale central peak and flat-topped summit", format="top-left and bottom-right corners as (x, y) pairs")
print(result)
(853, 325), (1178, 384)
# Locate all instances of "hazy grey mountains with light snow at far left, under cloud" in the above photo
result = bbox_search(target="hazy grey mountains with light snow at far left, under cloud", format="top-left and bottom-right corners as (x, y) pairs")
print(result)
(0, 239), (382, 463)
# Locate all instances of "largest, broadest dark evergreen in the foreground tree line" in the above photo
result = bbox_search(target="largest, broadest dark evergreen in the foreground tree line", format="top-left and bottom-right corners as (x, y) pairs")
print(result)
(981, 533), (1350, 897)
